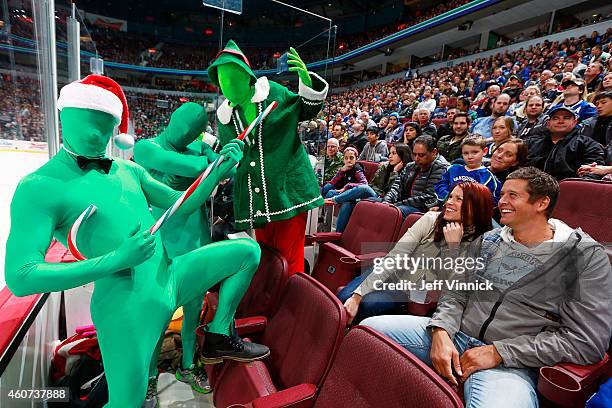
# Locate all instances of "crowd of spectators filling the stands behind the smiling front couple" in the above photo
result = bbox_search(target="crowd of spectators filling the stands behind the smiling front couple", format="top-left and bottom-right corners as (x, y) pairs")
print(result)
(318, 28), (612, 228)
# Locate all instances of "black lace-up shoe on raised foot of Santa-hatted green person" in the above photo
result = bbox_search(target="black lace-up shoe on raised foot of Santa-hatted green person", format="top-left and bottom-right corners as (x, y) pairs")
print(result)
(202, 332), (270, 364)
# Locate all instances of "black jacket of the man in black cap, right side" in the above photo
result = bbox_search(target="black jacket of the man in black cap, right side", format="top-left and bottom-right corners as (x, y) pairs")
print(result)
(527, 128), (605, 180)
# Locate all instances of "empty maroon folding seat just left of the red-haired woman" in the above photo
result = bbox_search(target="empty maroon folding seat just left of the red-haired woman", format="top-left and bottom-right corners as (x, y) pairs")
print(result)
(312, 200), (402, 293)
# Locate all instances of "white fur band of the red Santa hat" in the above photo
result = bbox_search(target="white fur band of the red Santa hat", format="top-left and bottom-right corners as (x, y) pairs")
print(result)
(57, 82), (123, 123)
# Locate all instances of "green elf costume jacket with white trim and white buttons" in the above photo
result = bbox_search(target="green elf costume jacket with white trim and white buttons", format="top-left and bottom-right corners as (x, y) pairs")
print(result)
(217, 72), (328, 229)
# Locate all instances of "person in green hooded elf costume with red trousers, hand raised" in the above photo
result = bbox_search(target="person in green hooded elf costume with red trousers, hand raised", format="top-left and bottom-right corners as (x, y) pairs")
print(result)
(208, 40), (328, 274)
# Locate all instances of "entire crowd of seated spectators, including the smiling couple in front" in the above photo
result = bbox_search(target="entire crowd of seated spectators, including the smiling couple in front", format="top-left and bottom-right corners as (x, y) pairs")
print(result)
(316, 23), (612, 407)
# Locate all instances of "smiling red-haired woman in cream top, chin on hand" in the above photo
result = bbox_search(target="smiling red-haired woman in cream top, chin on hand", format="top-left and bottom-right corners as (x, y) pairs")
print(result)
(338, 182), (493, 323)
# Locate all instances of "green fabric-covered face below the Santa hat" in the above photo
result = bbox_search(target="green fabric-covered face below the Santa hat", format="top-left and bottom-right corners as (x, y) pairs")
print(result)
(60, 108), (116, 157)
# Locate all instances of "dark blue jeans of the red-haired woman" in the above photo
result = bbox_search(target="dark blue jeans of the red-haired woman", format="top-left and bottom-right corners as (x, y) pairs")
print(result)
(338, 268), (409, 324)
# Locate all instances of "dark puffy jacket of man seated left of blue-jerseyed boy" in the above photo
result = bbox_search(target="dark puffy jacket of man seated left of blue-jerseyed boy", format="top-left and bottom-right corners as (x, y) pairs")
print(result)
(383, 155), (449, 212)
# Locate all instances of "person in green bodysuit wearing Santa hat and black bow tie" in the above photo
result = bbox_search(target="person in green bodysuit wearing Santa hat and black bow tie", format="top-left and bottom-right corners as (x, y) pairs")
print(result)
(5, 75), (269, 408)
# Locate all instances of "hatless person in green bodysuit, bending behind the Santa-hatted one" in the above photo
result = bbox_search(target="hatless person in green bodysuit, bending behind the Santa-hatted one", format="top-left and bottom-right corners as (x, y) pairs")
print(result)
(134, 102), (218, 399)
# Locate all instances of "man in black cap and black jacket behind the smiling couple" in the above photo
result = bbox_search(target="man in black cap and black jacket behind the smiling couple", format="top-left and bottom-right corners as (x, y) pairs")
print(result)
(527, 105), (605, 180)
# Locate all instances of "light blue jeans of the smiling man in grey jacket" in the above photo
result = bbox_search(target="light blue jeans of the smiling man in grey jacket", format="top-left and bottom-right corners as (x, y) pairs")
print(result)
(361, 316), (538, 408)
